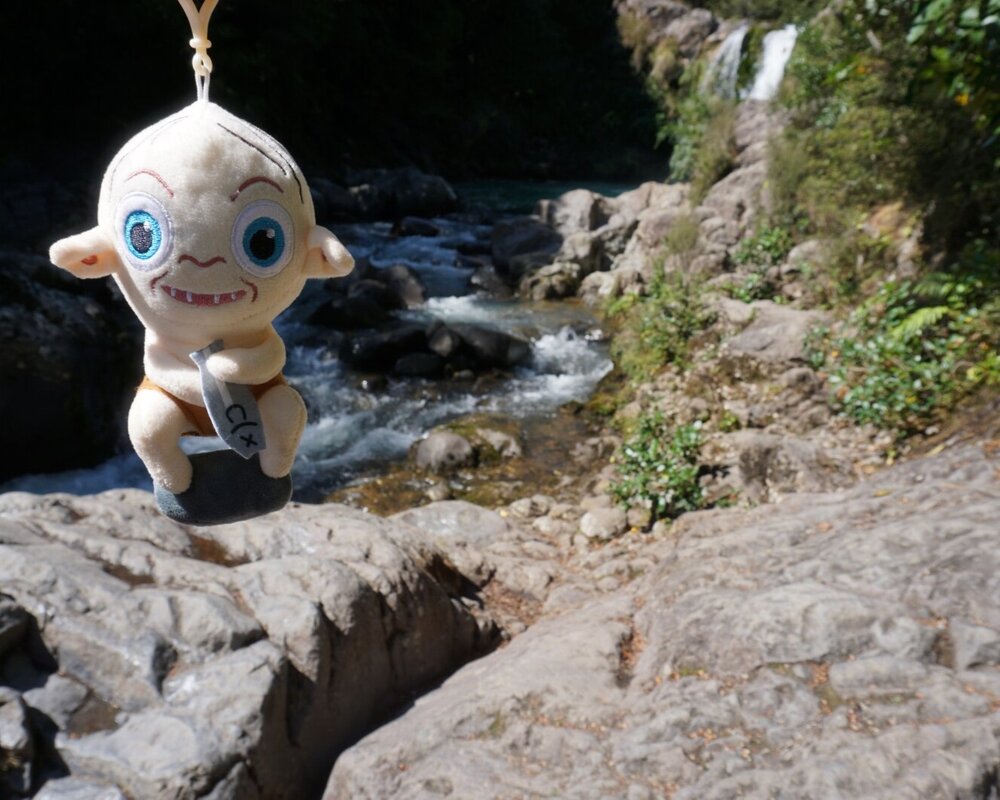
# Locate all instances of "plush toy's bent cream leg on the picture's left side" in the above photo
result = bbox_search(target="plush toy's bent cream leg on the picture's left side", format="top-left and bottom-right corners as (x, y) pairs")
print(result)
(128, 389), (194, 494)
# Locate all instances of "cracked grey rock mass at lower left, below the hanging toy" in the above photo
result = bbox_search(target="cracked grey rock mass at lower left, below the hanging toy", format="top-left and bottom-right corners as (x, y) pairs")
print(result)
(0, 491), (496, 800)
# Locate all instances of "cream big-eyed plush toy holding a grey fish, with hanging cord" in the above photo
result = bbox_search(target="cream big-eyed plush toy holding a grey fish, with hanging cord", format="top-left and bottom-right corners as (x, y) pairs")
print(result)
(49, 0), (354, 525)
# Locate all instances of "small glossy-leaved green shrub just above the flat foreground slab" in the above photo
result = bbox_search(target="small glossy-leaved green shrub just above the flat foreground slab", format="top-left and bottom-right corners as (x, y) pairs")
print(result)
(611, 412), (705, 520)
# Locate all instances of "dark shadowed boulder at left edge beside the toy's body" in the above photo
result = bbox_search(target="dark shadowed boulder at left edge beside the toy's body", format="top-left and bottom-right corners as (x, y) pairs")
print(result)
(0, 251), (142, 481)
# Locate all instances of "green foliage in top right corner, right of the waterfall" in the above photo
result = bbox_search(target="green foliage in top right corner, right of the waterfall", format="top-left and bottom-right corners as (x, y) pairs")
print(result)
(771, 0), (1000, 254)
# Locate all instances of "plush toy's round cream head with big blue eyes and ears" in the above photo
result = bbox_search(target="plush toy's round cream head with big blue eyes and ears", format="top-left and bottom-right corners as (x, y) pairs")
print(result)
(50, 101), (354, 341)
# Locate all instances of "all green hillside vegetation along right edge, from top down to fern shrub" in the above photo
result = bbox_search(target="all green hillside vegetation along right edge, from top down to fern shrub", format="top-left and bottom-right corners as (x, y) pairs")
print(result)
(770, 0), (1000, 435)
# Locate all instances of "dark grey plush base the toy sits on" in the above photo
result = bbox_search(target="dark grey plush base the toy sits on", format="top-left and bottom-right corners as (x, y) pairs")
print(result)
(153, 450), (292, 525)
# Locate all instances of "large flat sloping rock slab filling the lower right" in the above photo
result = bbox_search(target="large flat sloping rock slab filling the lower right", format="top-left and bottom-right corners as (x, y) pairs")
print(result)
(325, 442), (1000, 800)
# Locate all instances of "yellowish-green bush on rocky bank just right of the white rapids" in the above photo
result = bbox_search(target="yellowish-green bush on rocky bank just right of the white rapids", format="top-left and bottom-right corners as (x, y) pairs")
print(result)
(608, 266), (712, 383)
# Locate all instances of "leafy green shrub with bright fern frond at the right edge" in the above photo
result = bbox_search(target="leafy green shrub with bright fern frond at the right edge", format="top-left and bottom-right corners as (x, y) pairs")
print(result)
(812, 250), (1000, 436)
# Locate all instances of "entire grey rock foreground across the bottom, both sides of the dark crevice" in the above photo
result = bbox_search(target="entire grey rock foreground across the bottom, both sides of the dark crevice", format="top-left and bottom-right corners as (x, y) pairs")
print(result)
(0, 407), (1000, 800)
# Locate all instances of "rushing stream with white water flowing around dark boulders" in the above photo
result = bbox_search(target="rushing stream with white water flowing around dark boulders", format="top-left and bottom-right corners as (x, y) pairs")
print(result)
(0, 182), (630, 502)
